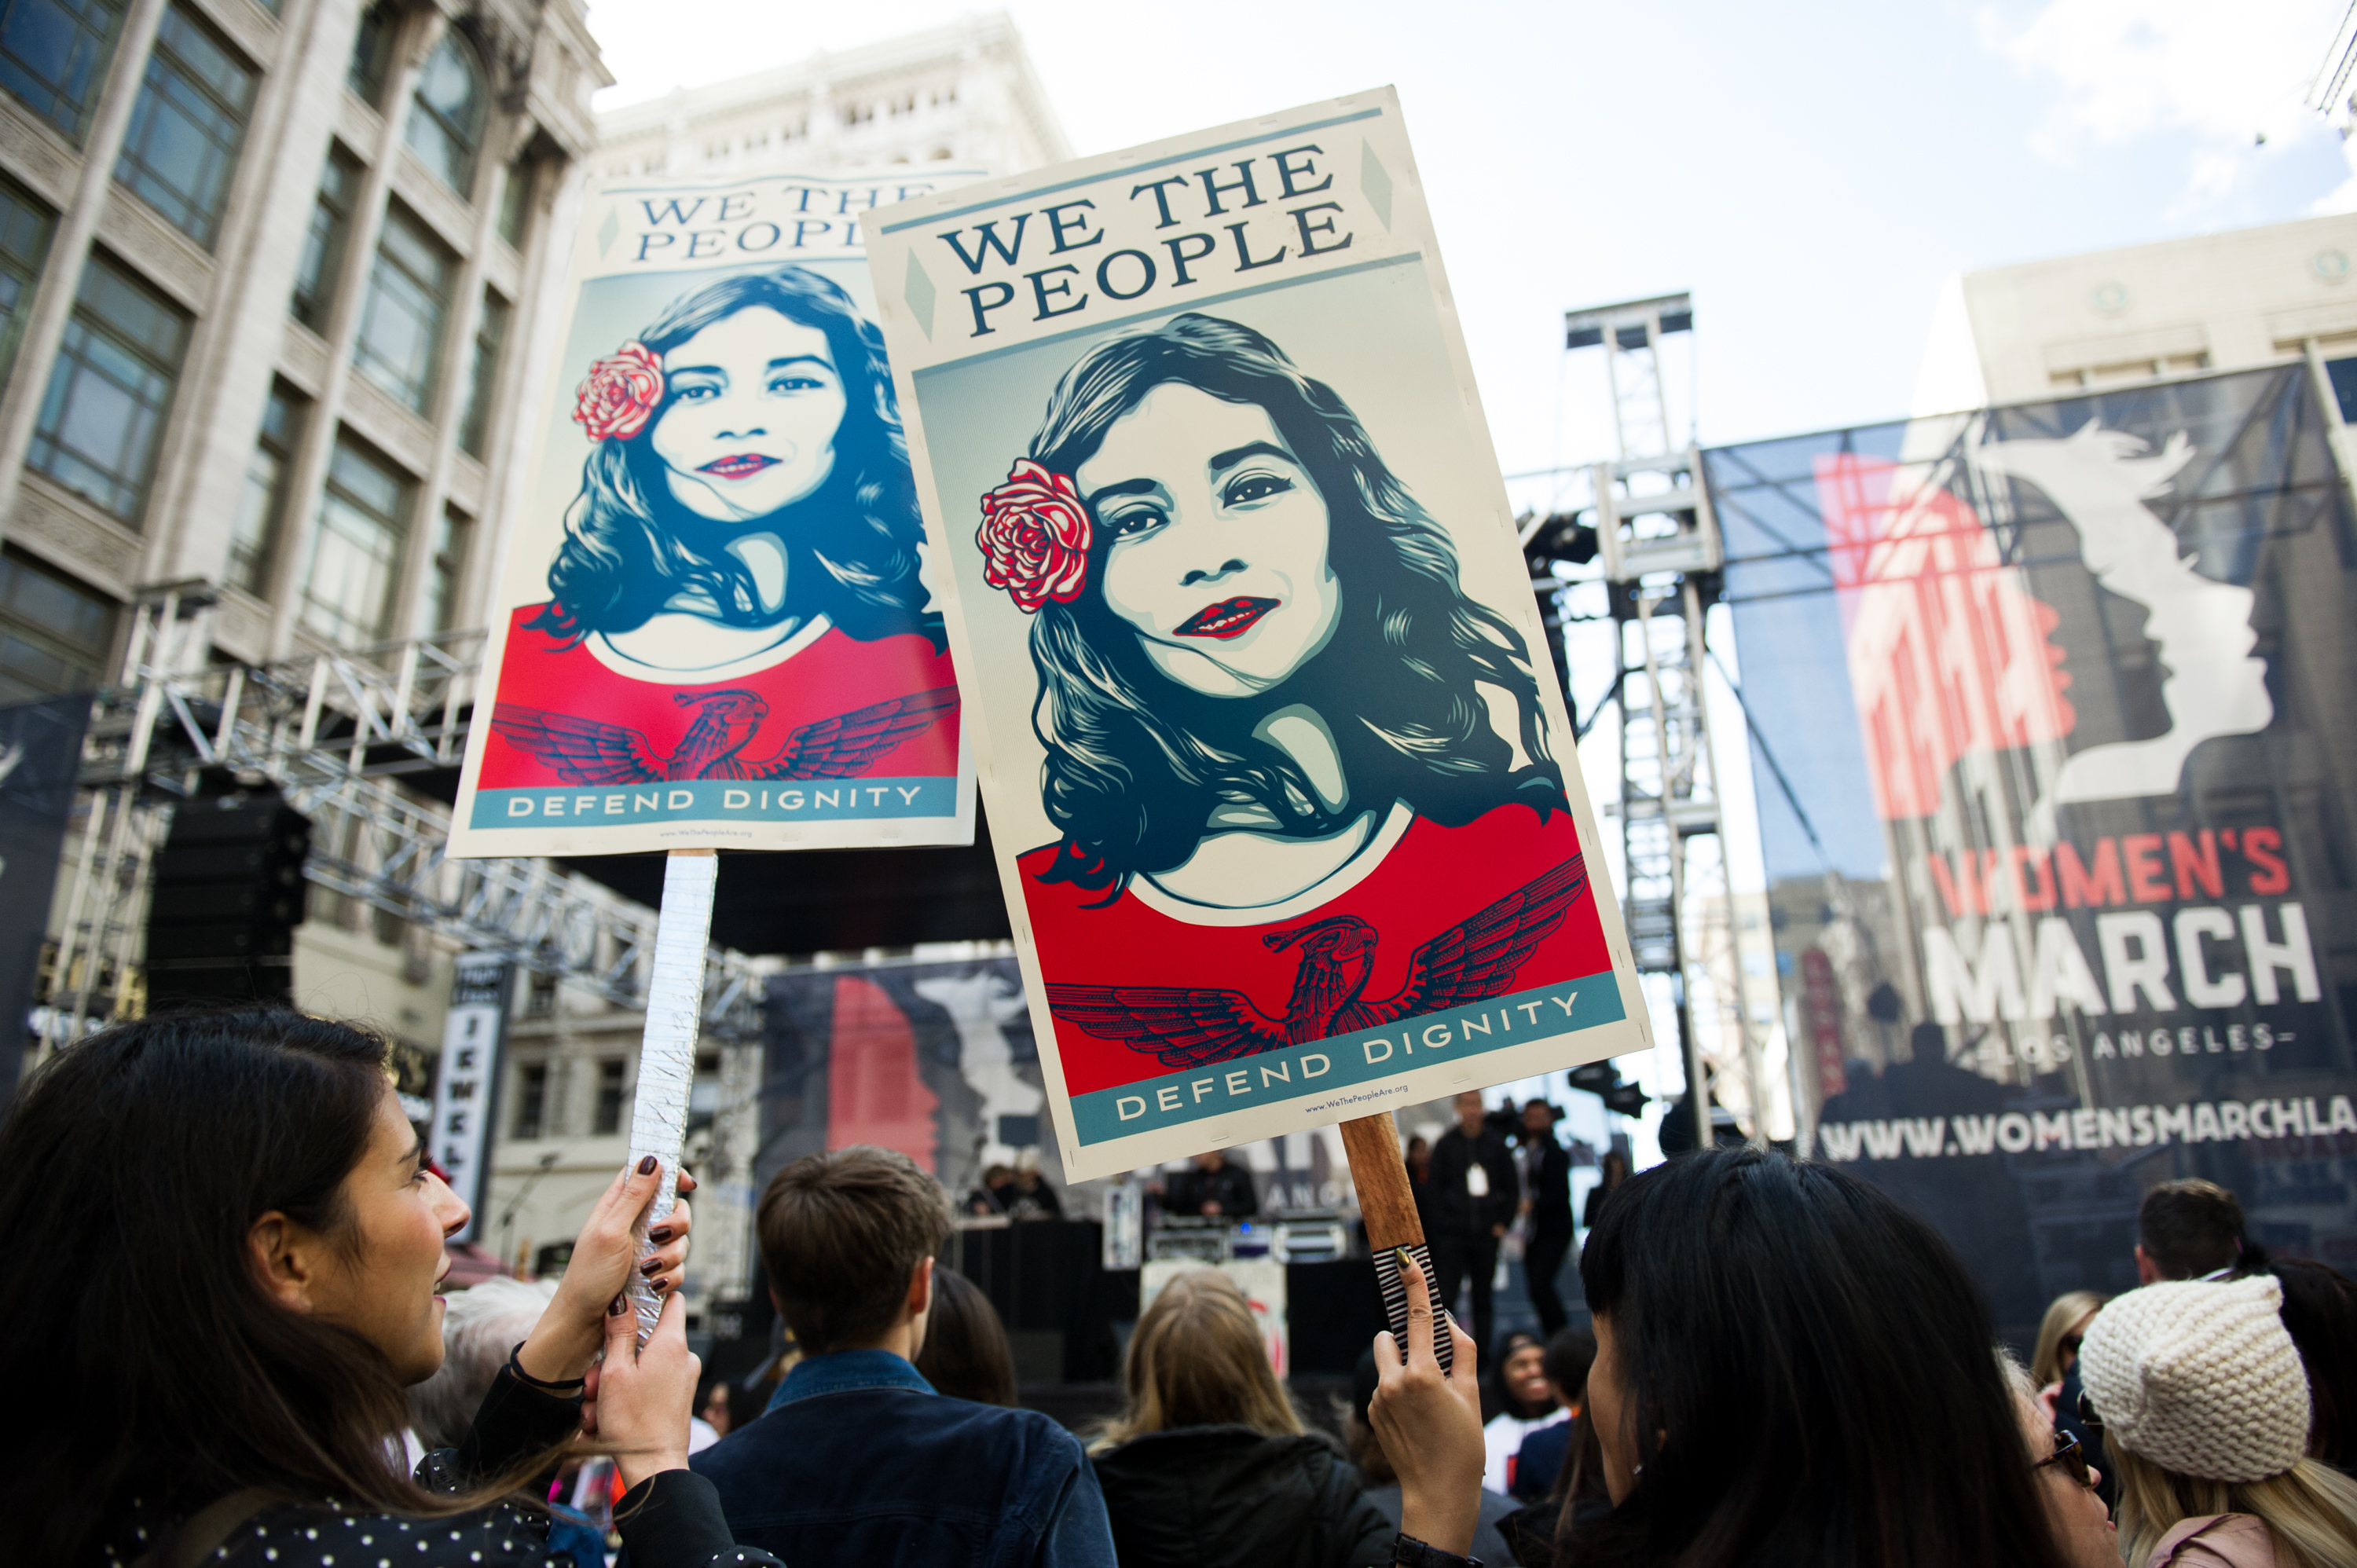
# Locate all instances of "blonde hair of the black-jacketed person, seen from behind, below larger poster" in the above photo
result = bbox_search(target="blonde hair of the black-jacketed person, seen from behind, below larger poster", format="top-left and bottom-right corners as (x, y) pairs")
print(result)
(1091, 1269), (1306, 1453)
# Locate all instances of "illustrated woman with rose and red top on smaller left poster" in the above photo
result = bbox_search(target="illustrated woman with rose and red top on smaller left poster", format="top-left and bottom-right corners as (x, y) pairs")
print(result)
(481, 266), (957, 788)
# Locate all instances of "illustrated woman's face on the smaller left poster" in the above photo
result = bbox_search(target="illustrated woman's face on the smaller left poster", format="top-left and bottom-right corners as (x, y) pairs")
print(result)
(648, 304), (846, 523)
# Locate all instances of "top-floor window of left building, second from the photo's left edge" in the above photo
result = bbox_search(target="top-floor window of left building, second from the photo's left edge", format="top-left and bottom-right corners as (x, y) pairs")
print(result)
(115, 5), (255, 247)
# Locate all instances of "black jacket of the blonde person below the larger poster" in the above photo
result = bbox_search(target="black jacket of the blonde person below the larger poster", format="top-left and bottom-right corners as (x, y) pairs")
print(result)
(1096, 1427), (1398, 1568)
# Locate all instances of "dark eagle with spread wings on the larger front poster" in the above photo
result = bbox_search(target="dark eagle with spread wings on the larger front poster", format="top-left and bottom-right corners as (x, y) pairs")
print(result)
(1047, 854), (1589, 1068)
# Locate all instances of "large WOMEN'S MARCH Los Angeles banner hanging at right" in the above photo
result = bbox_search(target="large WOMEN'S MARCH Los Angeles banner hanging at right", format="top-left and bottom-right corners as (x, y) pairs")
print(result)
(1704, 365), (2357, 1339)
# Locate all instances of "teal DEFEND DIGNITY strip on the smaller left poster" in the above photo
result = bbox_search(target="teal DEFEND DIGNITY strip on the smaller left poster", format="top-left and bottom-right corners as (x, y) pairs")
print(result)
(469, 778), (957, 828)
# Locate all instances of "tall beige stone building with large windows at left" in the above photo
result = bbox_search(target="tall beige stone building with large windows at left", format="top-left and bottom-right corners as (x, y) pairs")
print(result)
(0, 0), (613, 1061)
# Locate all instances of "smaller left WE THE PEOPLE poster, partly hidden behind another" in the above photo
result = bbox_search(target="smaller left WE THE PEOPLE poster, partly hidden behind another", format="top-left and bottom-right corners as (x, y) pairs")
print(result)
(450, 170), (976, 856)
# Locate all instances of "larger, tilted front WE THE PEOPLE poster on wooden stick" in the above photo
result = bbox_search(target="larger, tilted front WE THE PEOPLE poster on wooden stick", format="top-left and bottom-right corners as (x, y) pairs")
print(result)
(867, 90), (1645, 1177)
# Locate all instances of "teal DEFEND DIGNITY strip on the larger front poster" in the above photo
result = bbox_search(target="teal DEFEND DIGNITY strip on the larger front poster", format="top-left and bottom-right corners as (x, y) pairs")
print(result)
(1072, 969), (1626, 1144)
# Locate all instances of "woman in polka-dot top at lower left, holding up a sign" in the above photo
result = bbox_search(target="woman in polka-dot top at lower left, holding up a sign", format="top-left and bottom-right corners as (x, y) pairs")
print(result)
(0, 1009), (792, 1568)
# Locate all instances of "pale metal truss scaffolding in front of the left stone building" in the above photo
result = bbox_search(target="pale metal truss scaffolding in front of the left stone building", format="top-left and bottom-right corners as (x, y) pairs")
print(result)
(40, 584), (766, 1052)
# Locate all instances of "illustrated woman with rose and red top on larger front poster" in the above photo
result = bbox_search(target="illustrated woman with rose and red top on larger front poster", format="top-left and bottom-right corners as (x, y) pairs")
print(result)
(981, 313), (1607, 1092)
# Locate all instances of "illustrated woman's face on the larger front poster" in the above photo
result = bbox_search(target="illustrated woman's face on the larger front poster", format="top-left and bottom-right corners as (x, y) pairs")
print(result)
(1072, 382), (1341, 698)
